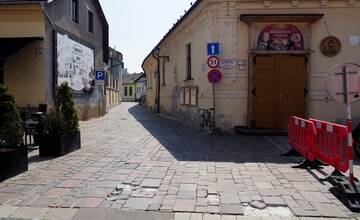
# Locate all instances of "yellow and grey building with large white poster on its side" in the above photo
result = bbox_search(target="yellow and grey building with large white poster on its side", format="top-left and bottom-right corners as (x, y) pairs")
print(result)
(0, 0), (109, 119)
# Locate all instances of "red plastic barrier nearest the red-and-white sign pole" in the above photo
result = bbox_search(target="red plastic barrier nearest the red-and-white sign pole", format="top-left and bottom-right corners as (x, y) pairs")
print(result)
(310, 119), (352, 173)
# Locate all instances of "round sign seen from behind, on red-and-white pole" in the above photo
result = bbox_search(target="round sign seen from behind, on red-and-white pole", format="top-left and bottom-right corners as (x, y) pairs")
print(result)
(326, 63), (360, 104)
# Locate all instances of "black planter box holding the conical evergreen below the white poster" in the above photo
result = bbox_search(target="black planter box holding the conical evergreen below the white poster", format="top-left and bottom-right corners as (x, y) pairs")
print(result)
(39, 131), (81, 157)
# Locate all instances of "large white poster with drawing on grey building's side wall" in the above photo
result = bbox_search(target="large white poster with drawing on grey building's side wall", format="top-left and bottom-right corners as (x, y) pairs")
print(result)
(57, 33), (95, 91)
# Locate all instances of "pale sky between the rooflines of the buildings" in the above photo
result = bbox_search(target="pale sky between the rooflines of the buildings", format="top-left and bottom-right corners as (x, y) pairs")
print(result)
(100, 0), (195, 73)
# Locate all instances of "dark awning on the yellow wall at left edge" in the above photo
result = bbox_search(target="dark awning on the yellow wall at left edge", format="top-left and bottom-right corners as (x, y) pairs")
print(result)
(0, 37), (42, 60)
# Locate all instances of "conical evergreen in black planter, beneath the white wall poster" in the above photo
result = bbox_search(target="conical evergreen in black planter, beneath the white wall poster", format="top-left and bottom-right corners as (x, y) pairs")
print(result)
(39, 82), (81, 157)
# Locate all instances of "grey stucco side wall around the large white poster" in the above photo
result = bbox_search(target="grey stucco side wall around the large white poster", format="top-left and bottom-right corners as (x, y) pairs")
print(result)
(45, 0), (106, 120)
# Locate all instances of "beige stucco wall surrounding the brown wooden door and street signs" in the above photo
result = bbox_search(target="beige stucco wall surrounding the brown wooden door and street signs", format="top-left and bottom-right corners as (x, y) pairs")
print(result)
(144, 0), (360, 130)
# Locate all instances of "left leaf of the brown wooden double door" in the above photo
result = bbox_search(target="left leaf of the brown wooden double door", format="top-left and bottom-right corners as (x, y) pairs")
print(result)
(252, 55), (280, 128)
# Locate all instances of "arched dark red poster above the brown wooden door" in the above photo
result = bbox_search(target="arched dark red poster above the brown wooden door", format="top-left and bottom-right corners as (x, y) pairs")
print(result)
(257, 24), (304, 50)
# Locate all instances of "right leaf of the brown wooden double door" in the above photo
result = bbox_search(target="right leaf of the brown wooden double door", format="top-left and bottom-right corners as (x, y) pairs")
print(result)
(278, 55), (307, 129)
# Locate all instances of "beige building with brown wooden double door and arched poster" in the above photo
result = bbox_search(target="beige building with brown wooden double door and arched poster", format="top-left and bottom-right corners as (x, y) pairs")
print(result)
(143, 0), (360, 131)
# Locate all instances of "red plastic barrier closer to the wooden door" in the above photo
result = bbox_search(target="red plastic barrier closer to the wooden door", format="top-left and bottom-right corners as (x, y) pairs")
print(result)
(289, 116), (316, 161)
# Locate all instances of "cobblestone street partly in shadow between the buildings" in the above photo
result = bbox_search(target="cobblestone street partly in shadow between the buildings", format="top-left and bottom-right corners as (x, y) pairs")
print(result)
(0, 103), (359, 220)
